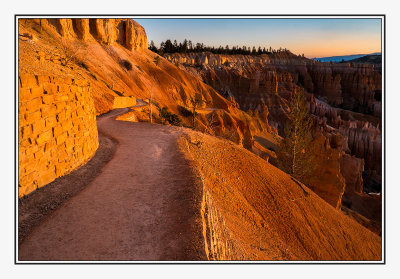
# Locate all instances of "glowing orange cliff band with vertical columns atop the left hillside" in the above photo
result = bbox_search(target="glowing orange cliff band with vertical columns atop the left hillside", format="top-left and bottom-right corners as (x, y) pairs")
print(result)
(40, 18), (148, 51)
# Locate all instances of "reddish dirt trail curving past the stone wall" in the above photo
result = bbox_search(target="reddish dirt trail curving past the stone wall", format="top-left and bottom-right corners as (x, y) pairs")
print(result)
(18, 109), (206, 260)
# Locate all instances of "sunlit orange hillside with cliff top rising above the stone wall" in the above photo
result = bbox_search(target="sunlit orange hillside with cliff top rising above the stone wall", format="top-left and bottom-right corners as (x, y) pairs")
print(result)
(19, 19), (271, 143)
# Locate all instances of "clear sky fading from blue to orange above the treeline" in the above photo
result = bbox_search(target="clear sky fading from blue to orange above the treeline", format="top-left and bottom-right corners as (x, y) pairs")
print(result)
(135, 18), (381, 58)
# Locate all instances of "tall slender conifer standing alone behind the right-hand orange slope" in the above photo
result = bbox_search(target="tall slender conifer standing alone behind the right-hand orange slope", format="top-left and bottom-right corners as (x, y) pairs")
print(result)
(278, 90), (315, 181)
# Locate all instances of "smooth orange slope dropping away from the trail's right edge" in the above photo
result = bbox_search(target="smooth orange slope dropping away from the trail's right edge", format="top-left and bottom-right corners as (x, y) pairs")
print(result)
(180, 131), (381, 261)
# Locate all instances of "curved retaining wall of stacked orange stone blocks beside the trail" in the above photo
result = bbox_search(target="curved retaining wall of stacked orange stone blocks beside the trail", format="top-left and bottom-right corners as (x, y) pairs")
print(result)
(18, 74), (99, 197)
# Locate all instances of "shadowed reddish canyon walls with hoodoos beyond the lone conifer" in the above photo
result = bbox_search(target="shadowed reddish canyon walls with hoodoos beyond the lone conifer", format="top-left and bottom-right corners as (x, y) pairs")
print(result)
(164, 52), (382, 207)
